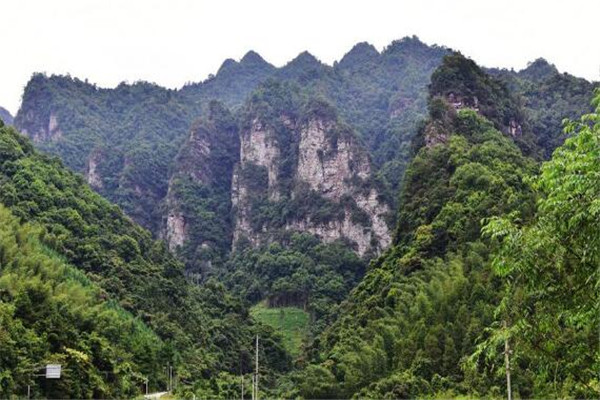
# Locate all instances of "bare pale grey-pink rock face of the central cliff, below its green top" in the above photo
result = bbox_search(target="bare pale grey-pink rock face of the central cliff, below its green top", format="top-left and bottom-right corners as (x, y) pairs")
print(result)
(232, 104), (391, 255)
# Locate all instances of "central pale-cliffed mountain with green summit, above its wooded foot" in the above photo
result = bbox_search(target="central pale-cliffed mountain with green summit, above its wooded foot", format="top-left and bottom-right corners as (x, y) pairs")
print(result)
(232, 83), (390, 255)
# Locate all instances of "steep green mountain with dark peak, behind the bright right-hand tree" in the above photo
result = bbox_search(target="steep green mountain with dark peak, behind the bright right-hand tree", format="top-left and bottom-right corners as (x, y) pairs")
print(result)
(283, 53), (597, 398)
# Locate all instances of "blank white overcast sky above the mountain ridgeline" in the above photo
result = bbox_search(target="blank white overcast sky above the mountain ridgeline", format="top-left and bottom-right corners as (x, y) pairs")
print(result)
(0, 0), (600, 114)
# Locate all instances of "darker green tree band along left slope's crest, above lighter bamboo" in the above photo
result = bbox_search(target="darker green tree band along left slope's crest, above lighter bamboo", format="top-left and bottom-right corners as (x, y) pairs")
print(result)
(0, 127), (289, 397)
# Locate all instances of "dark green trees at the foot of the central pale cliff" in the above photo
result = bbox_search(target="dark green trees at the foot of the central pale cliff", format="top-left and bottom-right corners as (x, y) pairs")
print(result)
(223, 233), (365, 344)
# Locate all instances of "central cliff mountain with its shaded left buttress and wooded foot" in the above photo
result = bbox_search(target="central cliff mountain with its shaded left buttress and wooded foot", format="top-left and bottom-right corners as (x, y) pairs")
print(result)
(165, 81), (391, 340)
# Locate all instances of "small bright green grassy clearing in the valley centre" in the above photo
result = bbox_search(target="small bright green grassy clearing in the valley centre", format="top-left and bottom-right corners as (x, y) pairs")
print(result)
(250, 302), (309, 357)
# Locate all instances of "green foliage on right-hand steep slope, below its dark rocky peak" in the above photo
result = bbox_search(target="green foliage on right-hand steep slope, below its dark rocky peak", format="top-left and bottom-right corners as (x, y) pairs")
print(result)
(292, 69), (535, 398)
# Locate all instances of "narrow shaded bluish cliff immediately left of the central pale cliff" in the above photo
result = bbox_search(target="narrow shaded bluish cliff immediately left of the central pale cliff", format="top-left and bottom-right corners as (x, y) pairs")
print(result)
(162, 102), (240, 273)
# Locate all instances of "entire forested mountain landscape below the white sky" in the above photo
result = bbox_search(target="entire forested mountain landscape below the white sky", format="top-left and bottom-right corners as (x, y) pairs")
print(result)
(0, 37), (600, 398)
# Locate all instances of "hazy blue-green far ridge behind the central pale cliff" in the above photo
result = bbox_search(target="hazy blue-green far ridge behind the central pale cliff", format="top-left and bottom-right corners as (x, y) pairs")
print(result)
(15, 38), (446, 246)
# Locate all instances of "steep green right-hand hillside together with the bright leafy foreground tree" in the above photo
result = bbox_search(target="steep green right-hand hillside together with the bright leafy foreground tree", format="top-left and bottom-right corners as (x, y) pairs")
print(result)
(285, 55), (600, 398)
